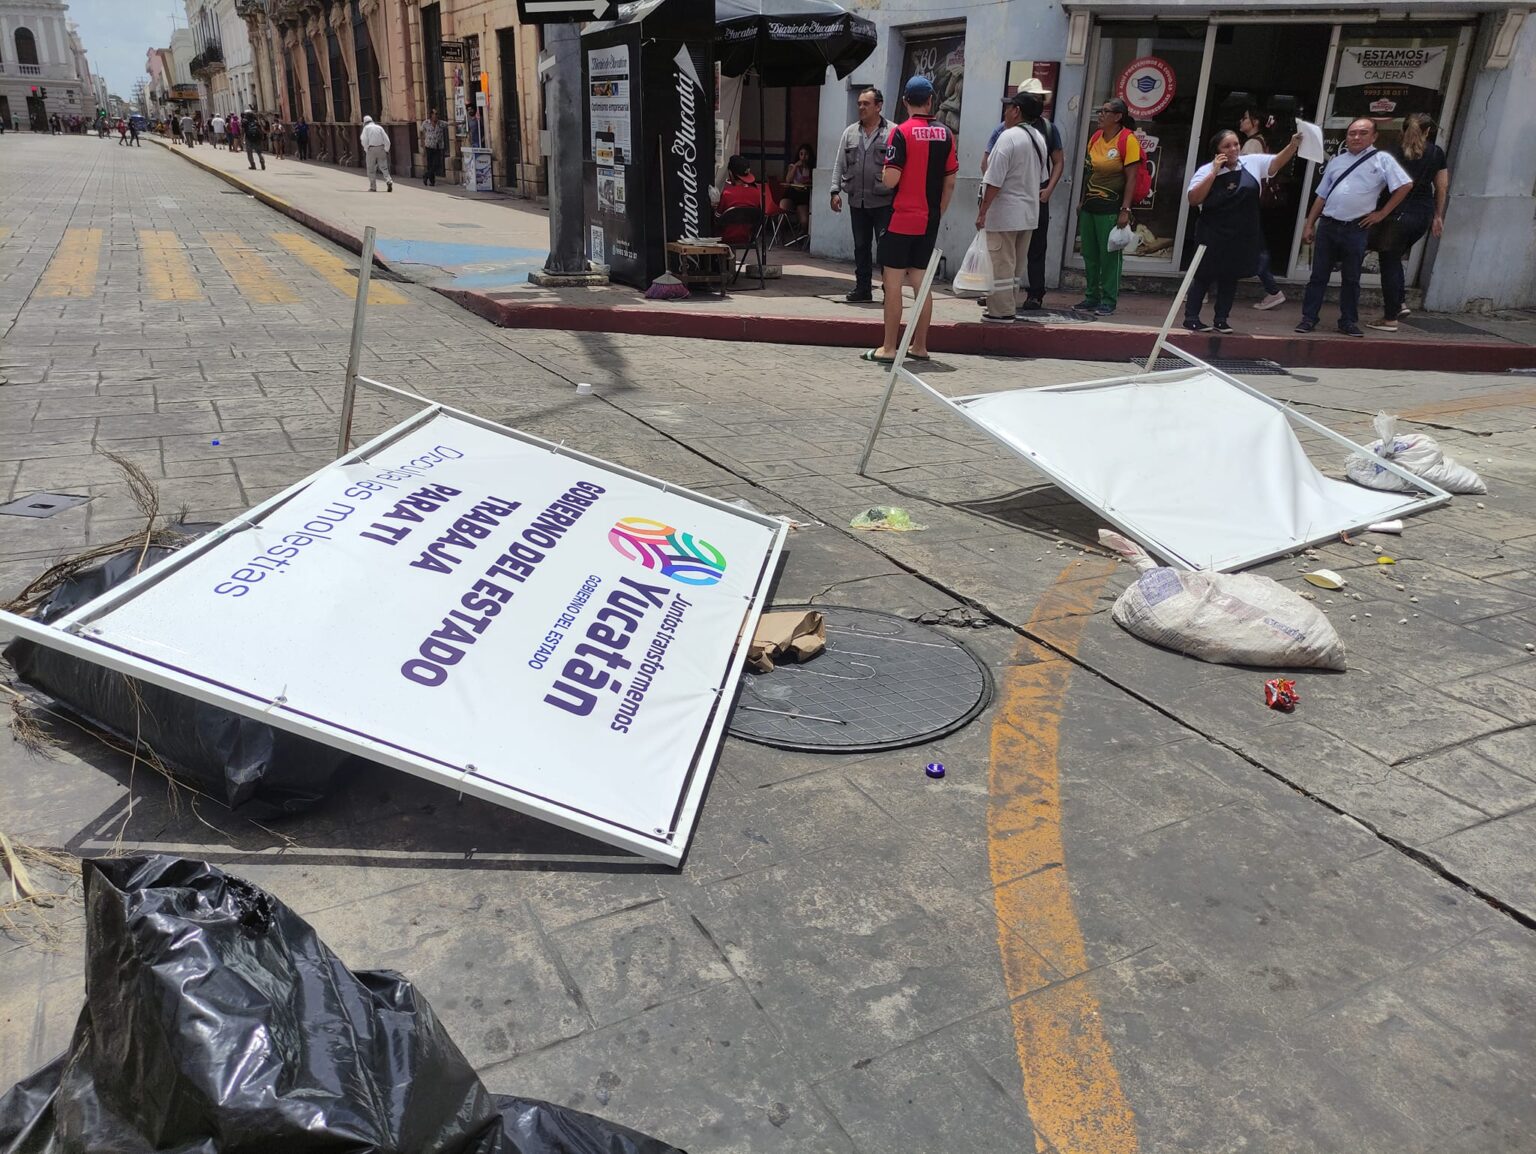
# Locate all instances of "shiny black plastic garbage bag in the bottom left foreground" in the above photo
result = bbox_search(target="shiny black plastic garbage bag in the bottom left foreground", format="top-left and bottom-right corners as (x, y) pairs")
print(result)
(0, 856), (682, 1154)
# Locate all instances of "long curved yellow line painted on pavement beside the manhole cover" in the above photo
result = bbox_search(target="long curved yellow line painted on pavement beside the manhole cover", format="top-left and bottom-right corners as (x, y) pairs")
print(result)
(988, 559), (1137, 1154)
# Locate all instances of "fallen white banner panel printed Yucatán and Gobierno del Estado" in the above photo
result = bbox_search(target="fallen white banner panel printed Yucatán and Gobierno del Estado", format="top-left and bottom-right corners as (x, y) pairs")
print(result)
(34, 410), (783, 862)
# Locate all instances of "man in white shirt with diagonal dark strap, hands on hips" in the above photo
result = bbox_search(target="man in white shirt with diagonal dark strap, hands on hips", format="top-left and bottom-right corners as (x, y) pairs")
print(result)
(1296, 117), (1413, 337)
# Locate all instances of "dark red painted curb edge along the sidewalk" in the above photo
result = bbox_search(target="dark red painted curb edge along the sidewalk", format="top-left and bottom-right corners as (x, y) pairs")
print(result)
(151, 137), (1536, 373)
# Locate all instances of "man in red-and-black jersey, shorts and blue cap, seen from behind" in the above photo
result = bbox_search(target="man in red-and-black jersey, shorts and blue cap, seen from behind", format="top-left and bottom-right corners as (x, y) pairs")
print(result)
(863, 75), (960, 364)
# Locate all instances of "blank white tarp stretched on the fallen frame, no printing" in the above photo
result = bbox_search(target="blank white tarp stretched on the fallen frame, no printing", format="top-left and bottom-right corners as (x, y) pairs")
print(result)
(958, 370), (1424, 572)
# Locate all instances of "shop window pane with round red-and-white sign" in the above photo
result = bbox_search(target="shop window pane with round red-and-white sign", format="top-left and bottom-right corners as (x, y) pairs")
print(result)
(1078, 22), (1206, 264)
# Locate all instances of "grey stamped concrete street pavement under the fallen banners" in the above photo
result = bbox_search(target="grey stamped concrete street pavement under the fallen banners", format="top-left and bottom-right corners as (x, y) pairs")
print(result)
(9, 130), (1536, 1154)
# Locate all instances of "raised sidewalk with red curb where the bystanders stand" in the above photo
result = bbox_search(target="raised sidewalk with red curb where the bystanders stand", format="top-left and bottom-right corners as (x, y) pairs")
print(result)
(151, 137), (1536, 372)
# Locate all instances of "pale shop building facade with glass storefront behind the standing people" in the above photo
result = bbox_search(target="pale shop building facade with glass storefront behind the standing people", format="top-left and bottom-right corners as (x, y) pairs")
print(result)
(804, 0), (1536, 310)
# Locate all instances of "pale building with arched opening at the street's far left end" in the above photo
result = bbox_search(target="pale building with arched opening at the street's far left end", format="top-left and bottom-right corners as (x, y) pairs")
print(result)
(0, 0), (95, 132)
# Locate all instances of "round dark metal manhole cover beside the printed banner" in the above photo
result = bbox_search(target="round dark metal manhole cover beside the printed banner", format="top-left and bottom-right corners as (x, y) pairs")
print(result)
(730, 605), (992, 751)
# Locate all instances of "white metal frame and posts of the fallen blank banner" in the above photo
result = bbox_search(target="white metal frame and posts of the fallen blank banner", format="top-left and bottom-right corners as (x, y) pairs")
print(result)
(859, 246), (1452, 572)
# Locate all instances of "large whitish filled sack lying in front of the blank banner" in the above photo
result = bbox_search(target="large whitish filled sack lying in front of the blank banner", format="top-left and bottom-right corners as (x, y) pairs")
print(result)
(1098, 529), (1346, 670)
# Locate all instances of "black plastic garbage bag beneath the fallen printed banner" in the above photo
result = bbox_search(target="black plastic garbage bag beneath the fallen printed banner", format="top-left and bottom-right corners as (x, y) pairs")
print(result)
(5, 524), (350, 817)
